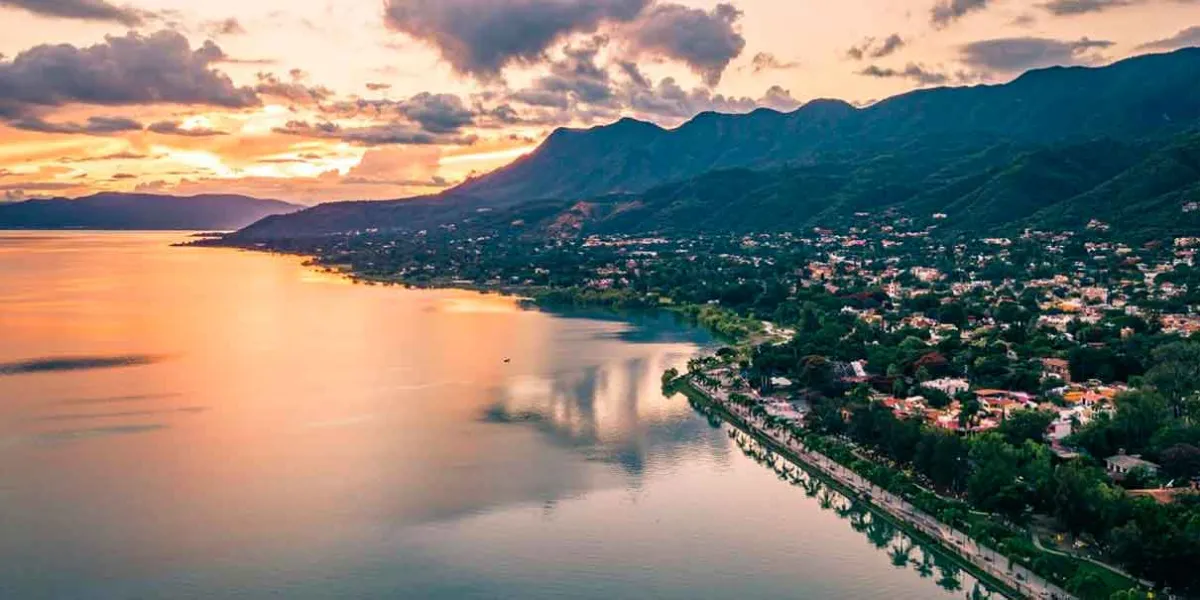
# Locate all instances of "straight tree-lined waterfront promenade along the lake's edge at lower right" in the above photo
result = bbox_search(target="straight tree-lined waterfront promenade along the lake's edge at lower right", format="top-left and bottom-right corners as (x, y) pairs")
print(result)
(691, 376), (1075, 600)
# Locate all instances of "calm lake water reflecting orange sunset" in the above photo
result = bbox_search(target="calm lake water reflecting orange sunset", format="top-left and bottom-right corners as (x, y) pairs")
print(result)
(0, 233), (982, 600)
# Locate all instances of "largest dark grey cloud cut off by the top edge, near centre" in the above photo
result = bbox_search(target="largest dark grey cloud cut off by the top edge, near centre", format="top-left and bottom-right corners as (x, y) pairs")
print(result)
(384, 0), (650, 78)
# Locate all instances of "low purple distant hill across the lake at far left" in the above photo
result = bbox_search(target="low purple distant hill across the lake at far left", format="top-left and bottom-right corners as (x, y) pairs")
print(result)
(0, 193), (304, 230)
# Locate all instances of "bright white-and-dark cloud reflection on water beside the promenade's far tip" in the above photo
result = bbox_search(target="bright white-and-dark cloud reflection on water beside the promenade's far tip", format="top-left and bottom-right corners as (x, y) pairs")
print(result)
(481, 353), (727, 475)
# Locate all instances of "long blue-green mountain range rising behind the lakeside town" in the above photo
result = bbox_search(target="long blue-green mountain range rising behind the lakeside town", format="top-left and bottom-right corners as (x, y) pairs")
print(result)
(225, 48), (1200, 241)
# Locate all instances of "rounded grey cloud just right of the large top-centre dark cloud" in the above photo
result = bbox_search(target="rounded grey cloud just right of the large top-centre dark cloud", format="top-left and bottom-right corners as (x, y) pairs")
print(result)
(622, 4), (746, 85)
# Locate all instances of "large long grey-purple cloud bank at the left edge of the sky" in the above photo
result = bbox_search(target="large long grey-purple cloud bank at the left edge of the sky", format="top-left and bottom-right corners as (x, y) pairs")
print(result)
(0, 31), (259, 119)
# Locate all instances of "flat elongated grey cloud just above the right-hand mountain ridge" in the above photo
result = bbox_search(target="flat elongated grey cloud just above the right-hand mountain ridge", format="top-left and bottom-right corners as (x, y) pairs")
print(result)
(961, 37), (1114, 73)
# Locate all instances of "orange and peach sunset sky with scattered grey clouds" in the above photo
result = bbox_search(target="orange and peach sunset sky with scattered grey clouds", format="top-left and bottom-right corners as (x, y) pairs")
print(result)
(0, 0), (1200, 204)
